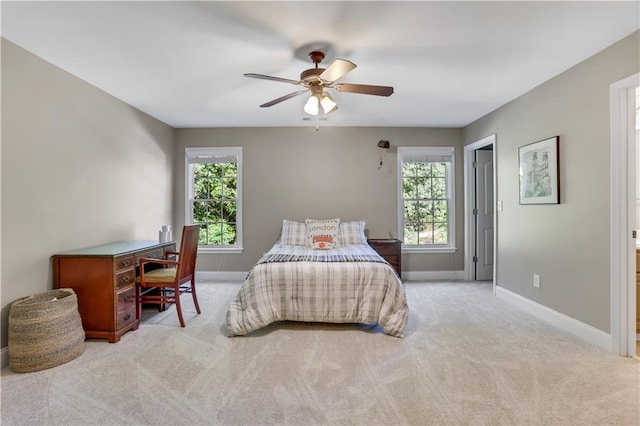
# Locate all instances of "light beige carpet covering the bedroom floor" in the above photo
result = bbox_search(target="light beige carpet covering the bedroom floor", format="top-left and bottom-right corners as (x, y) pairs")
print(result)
(1, 282), (640, 425)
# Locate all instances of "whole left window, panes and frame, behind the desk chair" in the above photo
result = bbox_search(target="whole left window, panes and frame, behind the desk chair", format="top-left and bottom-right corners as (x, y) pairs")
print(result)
(185, 147), (242, 252)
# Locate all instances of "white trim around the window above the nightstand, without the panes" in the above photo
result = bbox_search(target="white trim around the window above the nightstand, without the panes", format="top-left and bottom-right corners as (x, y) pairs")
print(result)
(396, 146), (458, 253)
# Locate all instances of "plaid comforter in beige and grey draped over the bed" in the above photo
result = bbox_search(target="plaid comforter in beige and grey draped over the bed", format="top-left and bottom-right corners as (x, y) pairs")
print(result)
(227, 244), (409, 337)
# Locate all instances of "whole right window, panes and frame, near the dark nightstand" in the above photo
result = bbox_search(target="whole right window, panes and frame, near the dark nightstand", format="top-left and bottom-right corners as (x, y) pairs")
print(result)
(398, 147), (456, 253)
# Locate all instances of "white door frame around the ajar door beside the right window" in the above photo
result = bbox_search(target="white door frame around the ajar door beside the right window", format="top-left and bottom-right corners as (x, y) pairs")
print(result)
(463, 133), (498, 295)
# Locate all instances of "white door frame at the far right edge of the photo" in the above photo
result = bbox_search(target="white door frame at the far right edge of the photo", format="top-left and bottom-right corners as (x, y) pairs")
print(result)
(610, 73), (640, 356)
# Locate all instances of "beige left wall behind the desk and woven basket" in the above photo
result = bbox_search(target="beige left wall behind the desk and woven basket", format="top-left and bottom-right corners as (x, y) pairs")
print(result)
(1, 39), (174, 347)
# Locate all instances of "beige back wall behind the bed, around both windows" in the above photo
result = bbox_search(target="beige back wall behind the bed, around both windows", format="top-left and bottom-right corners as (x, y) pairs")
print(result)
(174, 125), (464, 271)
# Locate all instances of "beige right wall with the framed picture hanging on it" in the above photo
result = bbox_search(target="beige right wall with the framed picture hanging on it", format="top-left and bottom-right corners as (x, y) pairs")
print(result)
(464, 32), (640, 332)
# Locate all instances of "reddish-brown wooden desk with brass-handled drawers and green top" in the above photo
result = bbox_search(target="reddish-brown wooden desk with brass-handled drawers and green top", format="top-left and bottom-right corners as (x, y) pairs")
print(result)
(52, 241), (176, 343)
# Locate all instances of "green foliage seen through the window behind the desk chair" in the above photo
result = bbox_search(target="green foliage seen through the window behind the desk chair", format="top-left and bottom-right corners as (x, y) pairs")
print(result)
(193, 163), (238, 245)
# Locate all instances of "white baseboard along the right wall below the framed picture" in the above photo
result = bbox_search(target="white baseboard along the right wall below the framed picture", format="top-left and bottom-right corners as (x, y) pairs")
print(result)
(496, 286), (611, 351)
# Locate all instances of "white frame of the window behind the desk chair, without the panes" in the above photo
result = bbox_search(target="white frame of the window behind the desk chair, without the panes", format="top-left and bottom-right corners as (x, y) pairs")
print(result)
(184, 147), (244, 253)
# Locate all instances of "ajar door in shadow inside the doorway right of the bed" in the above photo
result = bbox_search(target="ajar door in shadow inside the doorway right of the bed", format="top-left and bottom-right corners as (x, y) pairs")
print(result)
(474, 150), (494, 281)
